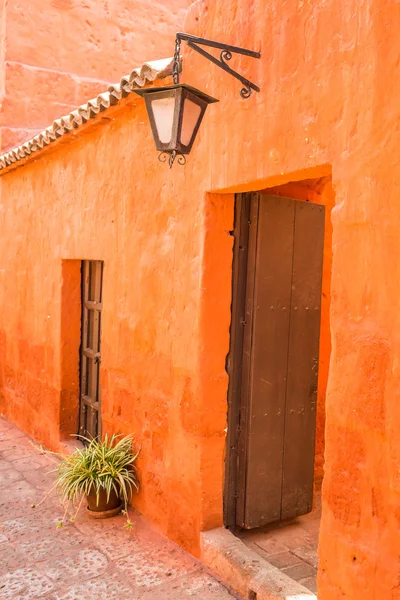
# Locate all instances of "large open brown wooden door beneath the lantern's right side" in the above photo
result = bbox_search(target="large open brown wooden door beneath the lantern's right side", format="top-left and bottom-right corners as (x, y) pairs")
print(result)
(228, 194), (324, 528)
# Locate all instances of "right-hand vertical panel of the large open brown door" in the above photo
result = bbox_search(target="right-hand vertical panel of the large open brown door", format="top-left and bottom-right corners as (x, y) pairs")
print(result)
(281, 202), (325, 519)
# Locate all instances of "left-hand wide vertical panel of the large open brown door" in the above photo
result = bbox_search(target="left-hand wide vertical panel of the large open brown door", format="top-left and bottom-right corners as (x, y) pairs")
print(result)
(242, 196), (295, 528)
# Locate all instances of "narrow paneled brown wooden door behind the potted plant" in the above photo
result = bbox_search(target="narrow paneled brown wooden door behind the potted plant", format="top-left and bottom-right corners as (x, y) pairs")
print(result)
(79, 260), (103, 438)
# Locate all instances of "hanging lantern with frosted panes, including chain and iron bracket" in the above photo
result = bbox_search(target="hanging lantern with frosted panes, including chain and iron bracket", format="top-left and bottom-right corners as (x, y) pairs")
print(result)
(135, 33), (260, 168)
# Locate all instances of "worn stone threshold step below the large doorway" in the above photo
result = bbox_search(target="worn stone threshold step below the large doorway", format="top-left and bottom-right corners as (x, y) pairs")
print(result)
(201, 527), (317, 600)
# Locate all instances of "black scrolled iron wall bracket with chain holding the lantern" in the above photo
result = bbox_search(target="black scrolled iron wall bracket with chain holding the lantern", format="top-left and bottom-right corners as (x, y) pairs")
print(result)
(172, 33), (261, 98)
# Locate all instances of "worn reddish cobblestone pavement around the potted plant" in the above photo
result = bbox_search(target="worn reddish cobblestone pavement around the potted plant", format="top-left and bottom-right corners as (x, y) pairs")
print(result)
(0, 417), (233, 600)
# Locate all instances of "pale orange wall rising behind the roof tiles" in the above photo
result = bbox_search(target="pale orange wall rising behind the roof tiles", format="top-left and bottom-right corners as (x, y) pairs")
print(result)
(0, 0), (191, 150)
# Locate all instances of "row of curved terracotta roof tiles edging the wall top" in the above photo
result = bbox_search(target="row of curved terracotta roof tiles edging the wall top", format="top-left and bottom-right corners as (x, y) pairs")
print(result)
(0, 58), (173, 174)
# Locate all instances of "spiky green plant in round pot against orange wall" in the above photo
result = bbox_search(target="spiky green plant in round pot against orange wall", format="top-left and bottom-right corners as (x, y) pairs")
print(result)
(32, 435), (139, 527)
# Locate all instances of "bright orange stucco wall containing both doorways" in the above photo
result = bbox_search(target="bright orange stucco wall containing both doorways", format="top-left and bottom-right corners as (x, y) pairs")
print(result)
(0, 0), (400, 600)
